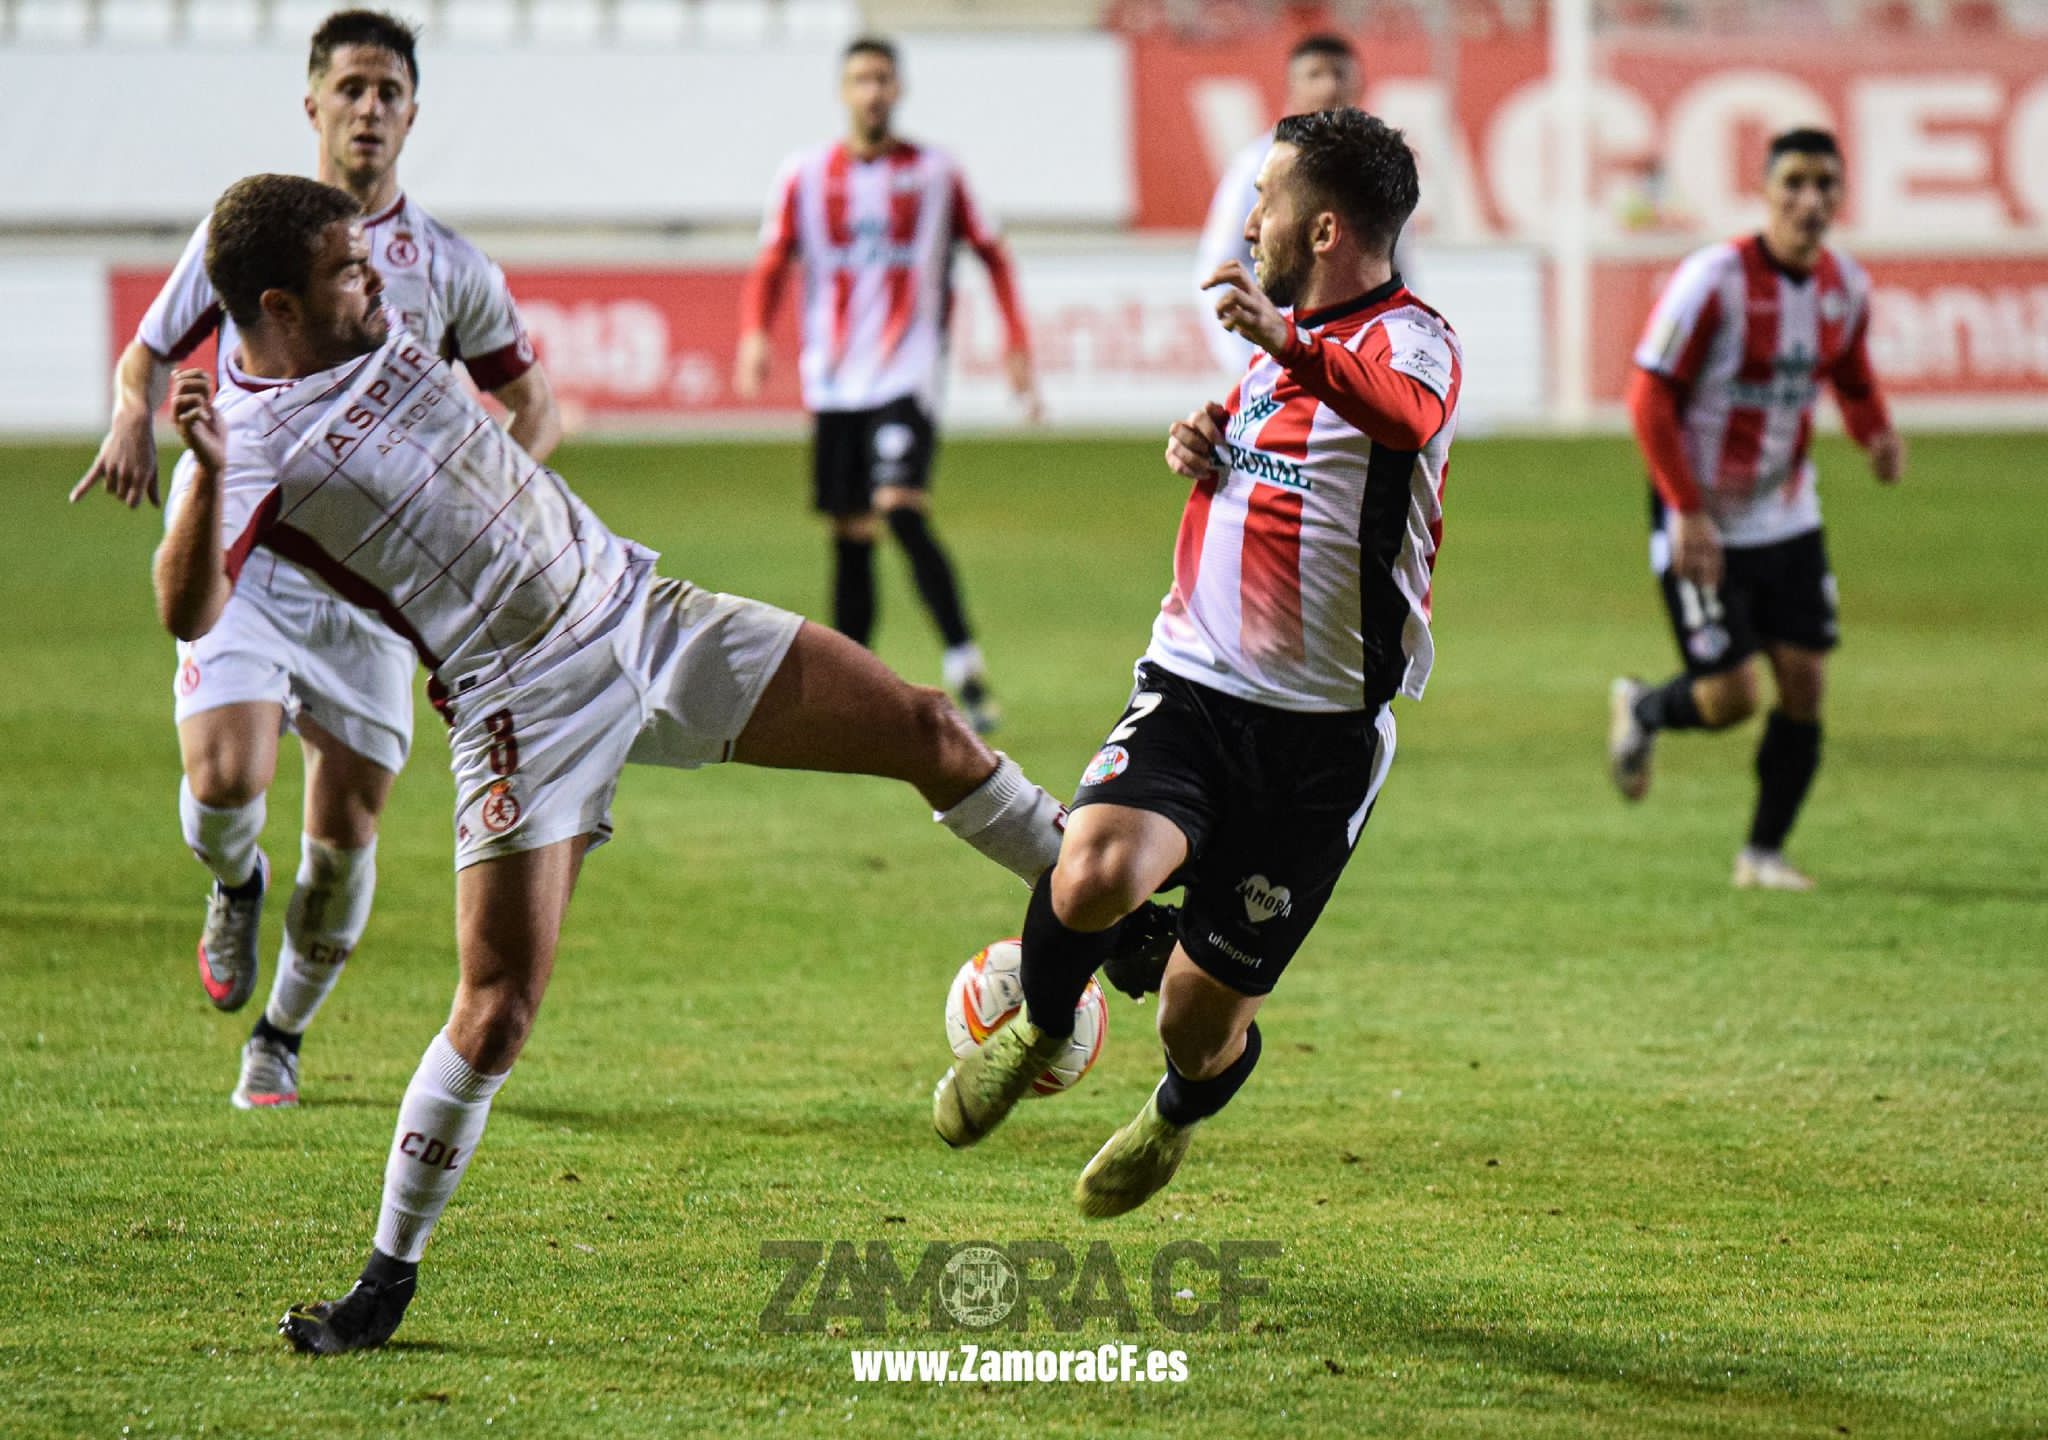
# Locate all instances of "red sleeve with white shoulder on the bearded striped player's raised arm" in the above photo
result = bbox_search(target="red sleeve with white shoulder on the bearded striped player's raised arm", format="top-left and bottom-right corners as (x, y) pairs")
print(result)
(1276, 315), (1462, 451)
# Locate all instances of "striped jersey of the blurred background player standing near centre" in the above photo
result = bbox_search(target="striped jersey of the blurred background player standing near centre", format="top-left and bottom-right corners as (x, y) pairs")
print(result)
(739, 141), (1026, 412)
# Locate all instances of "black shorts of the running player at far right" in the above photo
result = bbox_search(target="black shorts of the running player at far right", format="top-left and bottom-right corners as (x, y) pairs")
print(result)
(1657, 495), (1839, 676)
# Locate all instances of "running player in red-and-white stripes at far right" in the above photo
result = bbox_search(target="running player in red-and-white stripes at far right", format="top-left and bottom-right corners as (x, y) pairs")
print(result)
(1608, 129), (1905, 891)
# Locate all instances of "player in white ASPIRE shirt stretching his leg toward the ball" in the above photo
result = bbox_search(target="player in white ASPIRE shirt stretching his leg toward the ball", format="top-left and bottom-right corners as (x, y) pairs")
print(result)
(136, 176), (1171, 1354)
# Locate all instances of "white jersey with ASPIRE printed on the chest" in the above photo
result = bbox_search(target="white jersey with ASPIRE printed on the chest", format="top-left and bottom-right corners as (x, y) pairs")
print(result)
(207, 330), (655, 707)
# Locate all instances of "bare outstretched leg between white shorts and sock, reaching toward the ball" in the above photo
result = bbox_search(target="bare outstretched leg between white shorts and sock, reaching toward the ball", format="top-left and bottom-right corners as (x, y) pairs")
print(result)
(731, 621), (995, 809)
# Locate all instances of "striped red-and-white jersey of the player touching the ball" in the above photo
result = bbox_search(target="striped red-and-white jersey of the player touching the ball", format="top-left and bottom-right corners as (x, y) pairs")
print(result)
(1145, 274), (1464, 711)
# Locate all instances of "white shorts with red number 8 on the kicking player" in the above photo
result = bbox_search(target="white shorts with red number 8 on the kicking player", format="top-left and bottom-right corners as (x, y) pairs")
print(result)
(449, 576), (803, 871)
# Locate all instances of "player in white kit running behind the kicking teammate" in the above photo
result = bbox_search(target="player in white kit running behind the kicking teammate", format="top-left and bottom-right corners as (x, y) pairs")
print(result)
(74, 10), (561, 1108)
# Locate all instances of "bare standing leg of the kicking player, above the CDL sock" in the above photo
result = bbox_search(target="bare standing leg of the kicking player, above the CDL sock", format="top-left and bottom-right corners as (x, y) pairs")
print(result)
(449, 836), (588, 1073)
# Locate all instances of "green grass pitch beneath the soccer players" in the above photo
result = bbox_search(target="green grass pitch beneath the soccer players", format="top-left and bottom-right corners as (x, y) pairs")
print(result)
(0, 436), (2048, 1438)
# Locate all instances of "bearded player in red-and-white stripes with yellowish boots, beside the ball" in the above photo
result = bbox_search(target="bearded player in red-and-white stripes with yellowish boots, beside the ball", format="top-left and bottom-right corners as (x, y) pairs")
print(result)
(932, 109), (1462, 1217)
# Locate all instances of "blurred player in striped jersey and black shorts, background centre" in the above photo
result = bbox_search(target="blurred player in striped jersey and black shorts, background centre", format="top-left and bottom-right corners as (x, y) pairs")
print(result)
(733, 37), (1038, 733)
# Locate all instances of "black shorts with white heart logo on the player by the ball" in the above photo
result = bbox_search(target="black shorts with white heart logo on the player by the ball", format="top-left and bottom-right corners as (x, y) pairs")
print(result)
(1073, 664), (1393, 996)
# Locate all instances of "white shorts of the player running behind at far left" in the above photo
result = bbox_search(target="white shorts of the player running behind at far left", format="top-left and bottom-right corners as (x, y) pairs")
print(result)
(172, 553), (420, 772)
